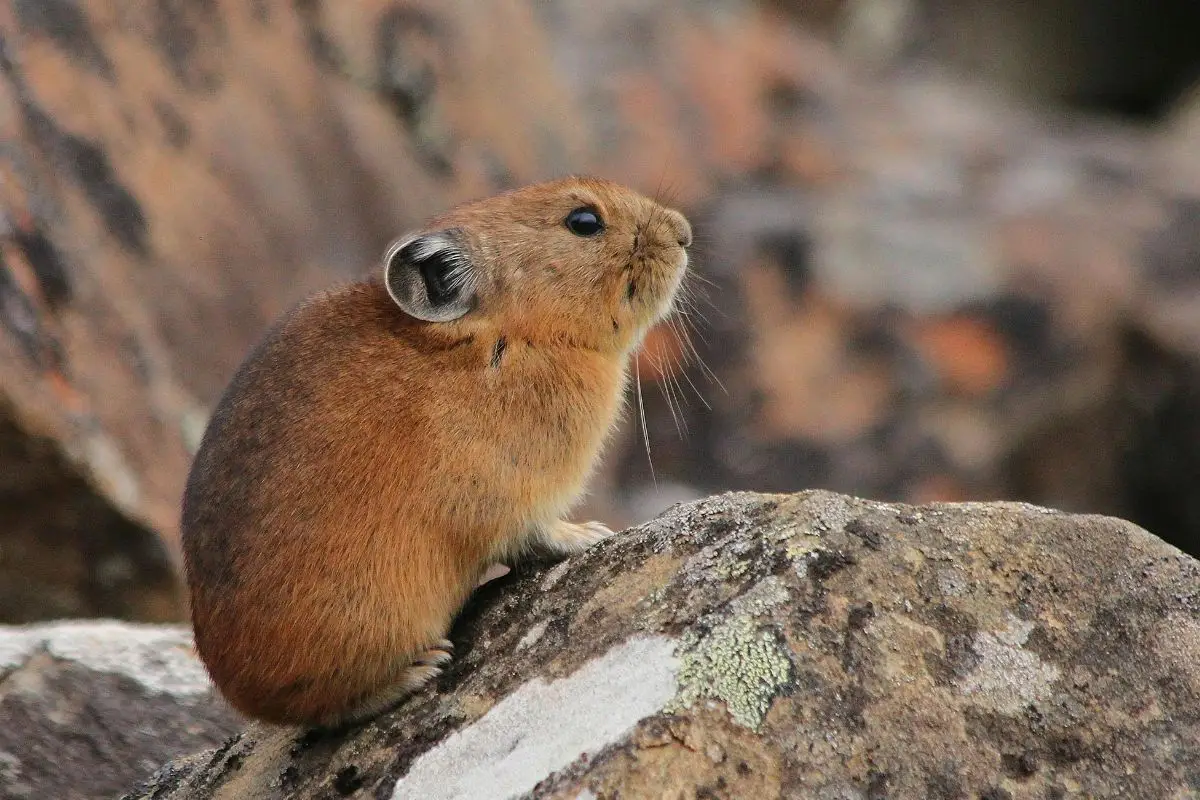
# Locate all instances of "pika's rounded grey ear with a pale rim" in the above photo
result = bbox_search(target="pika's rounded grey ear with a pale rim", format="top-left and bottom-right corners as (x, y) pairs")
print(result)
(383, 228), (478, 323)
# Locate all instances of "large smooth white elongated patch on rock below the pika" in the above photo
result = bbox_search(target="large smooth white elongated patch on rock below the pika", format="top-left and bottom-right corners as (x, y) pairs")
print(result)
(392, 636), (679, 800)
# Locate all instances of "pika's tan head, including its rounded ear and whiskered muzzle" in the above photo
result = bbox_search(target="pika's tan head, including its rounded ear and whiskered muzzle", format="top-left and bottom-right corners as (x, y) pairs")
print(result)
(384, 178), (691, 350)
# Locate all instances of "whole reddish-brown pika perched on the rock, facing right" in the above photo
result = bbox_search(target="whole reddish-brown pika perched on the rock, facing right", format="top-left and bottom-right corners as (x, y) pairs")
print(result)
(174, 178), (691, 726)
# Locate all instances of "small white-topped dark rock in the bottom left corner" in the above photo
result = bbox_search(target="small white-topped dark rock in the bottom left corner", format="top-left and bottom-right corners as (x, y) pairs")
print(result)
(0, 620), (240, 800)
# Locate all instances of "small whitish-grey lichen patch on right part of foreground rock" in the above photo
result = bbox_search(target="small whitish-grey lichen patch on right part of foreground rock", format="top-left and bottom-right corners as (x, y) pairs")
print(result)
(959, 616), (1060, 714)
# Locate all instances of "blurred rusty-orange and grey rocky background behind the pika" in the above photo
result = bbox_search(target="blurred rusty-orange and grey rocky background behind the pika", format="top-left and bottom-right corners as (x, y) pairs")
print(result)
(0, 0), (1200, 622)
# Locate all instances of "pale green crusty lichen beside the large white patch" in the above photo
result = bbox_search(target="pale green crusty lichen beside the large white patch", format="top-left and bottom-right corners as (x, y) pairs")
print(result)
(667, 615), (792, 730)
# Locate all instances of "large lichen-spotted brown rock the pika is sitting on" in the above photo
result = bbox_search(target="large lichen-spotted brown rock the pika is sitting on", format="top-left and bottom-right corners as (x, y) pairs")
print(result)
(119, 492), (1200, 800)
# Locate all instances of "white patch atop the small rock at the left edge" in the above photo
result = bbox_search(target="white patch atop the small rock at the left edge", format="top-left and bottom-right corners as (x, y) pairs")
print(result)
(0, 620), (212, 697)
